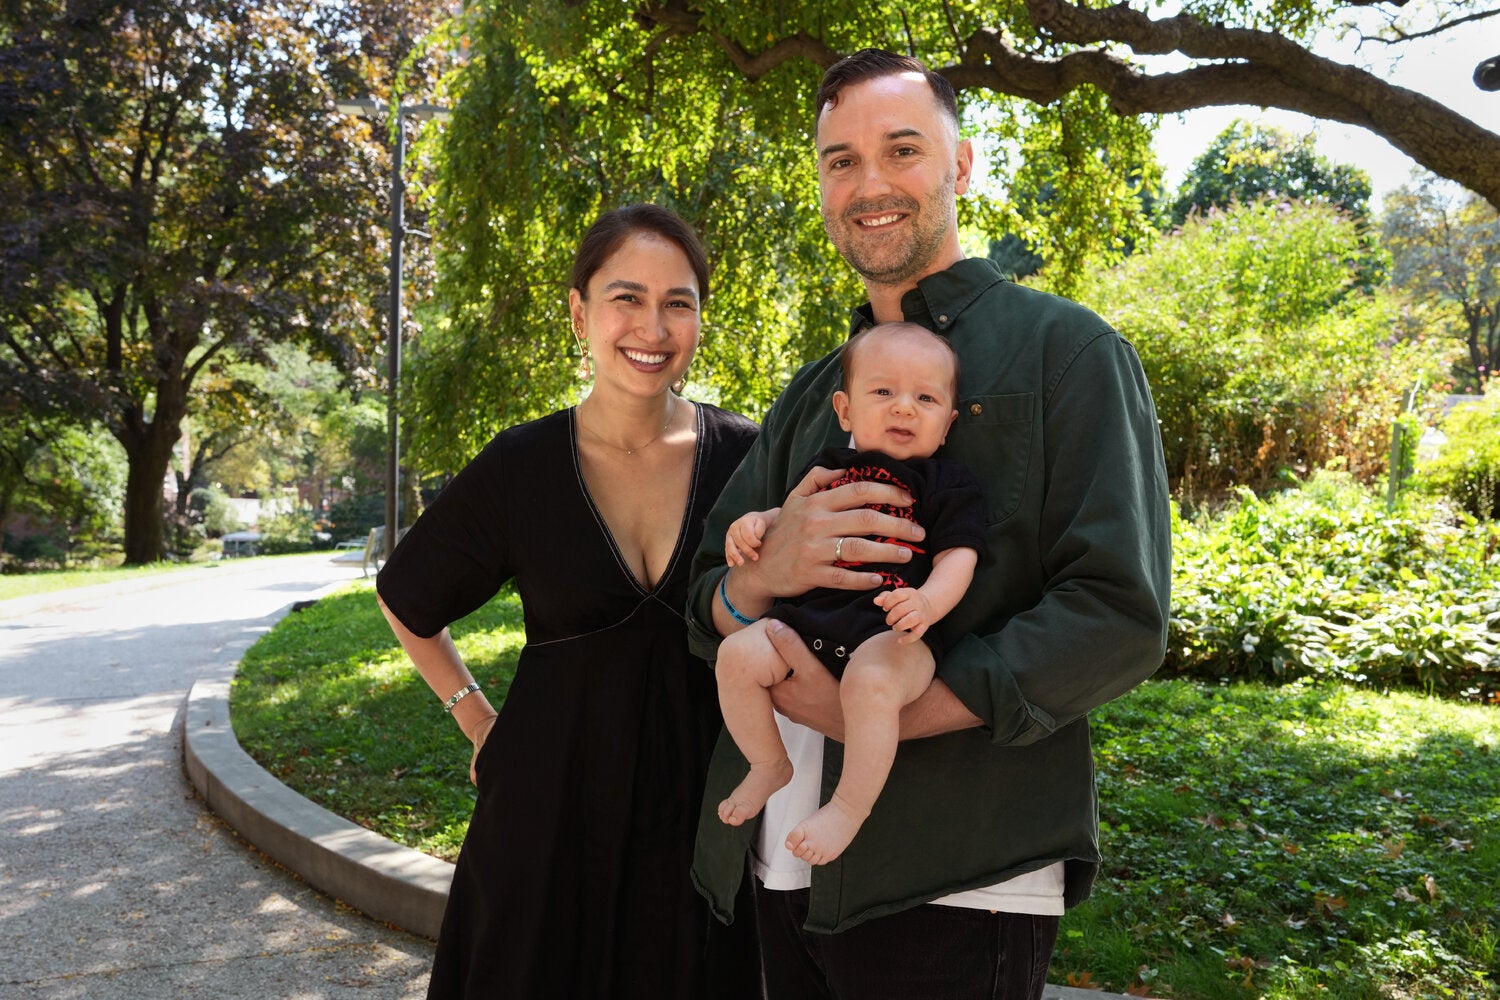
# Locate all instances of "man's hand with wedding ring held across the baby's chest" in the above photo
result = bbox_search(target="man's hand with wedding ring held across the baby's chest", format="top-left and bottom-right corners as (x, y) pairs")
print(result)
(729, 468), (926, 615)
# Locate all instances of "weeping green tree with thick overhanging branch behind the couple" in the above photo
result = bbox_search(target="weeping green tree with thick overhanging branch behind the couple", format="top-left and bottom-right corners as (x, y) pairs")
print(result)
(423, 0), (1500, 474)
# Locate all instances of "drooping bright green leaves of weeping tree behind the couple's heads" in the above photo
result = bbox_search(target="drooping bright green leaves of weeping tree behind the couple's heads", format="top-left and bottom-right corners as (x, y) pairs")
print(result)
(404, 0), (1146, 474)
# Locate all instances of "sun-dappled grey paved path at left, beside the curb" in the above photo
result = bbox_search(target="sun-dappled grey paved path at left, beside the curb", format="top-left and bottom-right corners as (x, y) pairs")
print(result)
(0, 555), (432, 1000)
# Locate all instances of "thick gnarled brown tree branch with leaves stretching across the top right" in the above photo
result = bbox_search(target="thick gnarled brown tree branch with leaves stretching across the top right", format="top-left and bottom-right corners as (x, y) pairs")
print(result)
(624, 0), (1500, 205)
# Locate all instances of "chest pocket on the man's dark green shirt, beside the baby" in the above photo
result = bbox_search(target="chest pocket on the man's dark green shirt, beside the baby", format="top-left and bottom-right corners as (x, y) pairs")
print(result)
(942, 393), (1037, 525)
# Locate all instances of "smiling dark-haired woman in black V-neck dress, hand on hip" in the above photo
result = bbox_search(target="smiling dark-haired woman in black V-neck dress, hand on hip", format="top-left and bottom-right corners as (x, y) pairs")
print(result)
(378, 205), (761, 1000)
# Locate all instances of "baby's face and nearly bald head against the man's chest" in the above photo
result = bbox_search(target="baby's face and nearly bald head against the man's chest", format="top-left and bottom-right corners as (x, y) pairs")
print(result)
(834, 331), (959, 459)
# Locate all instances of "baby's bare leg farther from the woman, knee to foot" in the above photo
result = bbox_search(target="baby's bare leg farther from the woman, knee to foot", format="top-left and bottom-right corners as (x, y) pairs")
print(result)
(786, 631), (935, 865)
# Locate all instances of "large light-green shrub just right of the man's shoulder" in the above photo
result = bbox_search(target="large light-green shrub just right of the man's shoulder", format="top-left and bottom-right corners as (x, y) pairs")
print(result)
(1080, 201), (1446, 496)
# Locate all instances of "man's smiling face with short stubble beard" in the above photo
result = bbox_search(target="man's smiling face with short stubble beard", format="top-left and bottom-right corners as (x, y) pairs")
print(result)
(818, 73), (974, 285)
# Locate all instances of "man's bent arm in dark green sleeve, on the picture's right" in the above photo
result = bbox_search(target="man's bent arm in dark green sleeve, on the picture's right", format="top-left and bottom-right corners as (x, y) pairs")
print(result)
(938, 331), (1172, 745)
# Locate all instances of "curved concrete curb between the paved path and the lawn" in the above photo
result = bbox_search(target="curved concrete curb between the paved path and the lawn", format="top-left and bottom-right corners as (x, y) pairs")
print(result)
(183, 668), (453, 939)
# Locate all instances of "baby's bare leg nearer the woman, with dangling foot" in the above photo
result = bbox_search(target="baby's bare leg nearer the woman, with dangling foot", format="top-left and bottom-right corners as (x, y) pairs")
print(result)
(714, 619), (792, 826)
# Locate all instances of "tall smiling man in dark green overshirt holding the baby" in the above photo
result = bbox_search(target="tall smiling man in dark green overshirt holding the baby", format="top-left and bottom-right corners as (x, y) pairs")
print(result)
(689, 49), (1170, 1000)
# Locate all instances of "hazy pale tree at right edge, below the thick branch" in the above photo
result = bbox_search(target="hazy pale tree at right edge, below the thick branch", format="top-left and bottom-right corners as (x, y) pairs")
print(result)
(1382, 178), (1500, 391)
